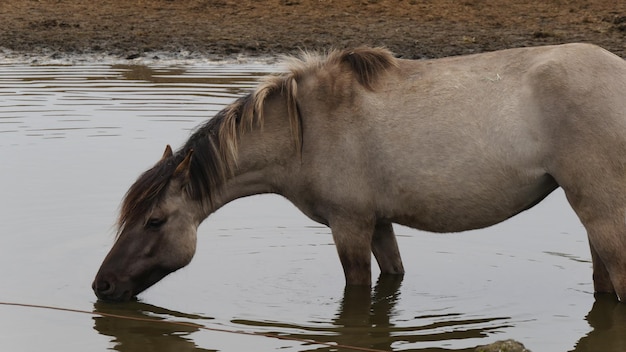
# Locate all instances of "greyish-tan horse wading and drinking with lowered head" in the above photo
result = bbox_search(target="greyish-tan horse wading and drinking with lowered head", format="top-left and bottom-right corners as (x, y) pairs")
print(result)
(92, 43), (626, 301)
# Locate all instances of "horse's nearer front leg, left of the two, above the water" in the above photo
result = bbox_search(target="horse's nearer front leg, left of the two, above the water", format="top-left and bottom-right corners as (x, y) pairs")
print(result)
(330, 218), (374, 286)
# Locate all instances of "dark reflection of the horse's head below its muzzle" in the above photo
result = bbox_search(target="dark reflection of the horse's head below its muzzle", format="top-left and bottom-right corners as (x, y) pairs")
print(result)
(93, 302), (214, 352)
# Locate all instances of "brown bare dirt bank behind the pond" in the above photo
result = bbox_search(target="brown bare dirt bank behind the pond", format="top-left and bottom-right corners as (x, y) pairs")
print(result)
(0, 0), (626, 59)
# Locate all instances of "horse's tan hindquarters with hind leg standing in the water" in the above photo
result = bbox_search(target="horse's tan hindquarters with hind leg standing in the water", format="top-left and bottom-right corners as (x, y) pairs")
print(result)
(525, 44), (626, 301)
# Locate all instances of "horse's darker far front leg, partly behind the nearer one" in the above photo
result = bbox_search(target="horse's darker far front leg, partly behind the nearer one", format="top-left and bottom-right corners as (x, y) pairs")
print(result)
(372, 222), (404, 275)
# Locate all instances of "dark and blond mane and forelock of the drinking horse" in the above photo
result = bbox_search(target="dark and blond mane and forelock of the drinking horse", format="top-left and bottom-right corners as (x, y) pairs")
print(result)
(118, 47), (397, 233)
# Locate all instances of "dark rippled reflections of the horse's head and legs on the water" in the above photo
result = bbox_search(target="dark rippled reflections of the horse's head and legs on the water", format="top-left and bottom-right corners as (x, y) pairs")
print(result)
(93, 262), (626, 352)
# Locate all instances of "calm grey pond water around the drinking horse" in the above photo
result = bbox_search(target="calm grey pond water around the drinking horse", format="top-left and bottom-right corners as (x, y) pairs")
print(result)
(0, 62), (626, 352)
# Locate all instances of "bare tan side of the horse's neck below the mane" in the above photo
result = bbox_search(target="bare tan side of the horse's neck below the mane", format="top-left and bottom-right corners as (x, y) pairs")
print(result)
(202, 95), (300, 213)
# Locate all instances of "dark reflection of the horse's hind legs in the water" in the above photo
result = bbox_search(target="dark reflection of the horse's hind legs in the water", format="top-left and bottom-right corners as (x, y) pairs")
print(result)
(573, 294), (626, 352)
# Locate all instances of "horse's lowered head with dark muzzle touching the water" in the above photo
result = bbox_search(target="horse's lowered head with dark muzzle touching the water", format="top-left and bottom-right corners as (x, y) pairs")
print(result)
(92, 146), (202, 301)
